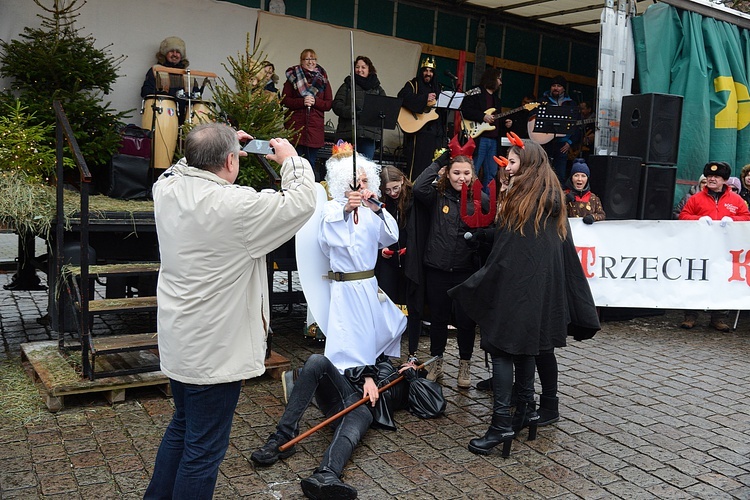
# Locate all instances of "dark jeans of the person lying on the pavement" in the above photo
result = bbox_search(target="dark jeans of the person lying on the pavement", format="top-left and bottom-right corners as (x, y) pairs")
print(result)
(276, 354), (372, 476)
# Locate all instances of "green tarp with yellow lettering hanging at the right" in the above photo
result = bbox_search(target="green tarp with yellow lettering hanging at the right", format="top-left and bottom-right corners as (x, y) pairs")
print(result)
(632, 4), (750, 199)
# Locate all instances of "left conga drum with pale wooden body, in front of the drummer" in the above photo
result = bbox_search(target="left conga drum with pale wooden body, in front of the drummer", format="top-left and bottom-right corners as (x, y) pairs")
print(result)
(141, 95), (180, 169)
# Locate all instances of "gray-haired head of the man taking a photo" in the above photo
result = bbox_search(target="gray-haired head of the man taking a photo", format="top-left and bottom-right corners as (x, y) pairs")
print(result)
(185, 123), (240, 172)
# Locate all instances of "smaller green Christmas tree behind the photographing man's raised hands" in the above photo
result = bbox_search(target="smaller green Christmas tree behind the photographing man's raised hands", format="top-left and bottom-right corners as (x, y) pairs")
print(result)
(212, 33), (294, 187)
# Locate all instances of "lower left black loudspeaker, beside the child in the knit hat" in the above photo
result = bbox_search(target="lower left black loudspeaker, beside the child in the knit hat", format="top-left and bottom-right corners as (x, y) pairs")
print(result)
(587, 155), (641, 220)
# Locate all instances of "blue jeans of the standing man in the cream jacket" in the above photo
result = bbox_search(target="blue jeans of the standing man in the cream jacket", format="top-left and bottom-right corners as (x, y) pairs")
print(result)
(143, 379), (242, 500)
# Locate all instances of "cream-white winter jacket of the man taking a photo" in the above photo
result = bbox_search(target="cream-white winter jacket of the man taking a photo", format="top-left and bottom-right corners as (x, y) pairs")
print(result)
(153, 157), (315, 385)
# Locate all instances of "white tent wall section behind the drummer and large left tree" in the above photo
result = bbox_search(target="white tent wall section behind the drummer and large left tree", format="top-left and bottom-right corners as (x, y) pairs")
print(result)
(0, 0), (258, 125)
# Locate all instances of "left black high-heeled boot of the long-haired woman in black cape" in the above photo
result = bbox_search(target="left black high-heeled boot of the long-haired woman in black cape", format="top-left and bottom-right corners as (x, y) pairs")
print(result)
(469, 356), (515, 458)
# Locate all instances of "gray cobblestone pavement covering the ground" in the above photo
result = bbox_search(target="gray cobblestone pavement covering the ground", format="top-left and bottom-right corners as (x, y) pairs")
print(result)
(0, 275), (750, 499)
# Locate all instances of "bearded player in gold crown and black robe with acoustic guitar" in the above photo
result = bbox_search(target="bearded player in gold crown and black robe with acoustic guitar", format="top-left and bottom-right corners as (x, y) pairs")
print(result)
(398, 57), (445, 181)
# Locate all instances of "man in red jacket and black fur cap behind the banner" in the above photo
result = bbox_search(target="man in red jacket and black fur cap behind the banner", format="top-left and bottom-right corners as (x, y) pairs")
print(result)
(680, 161), (750, 332)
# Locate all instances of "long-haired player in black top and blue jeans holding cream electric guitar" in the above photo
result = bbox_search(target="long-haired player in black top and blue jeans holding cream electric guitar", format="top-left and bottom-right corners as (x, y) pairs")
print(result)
(461, 68), (506, 193)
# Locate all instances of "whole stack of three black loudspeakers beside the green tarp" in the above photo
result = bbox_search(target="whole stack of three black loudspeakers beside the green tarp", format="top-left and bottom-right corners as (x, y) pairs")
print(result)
(588, 94), (682, 220)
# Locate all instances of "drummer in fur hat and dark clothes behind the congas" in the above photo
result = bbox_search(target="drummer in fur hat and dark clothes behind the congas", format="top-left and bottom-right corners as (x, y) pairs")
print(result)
(141, 36), (199, 124)
